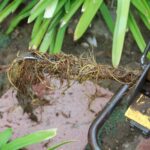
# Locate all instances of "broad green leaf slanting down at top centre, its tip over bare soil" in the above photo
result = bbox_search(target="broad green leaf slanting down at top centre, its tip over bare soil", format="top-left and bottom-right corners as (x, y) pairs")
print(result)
(74, 0), (103, 40)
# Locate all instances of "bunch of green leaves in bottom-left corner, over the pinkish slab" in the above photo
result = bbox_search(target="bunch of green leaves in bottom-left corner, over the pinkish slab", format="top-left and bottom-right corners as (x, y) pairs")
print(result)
(0, 128), (72, 150)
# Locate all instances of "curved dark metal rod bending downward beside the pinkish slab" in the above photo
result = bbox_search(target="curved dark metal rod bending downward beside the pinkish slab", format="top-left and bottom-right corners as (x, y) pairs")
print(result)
(88, 85), (129, 150)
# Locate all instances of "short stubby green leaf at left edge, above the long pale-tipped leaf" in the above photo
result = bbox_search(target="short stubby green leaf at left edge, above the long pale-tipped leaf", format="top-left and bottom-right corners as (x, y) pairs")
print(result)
(0, 128), (12, 147)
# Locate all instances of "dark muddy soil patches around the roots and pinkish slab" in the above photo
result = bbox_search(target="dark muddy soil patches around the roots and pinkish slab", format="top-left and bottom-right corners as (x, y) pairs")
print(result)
(0, 15), (150, 150)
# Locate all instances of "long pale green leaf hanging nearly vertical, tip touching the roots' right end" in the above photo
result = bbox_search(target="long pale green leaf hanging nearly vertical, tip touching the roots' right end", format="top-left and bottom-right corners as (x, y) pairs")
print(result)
(112, 0), (130, 68)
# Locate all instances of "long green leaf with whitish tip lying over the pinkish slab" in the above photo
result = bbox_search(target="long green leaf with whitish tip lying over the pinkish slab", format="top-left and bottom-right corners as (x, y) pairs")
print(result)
(1, 129), (57, 150)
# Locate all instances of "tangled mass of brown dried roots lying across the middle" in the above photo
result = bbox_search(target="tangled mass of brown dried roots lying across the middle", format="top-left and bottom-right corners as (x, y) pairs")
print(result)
(8, 52), (140, 93)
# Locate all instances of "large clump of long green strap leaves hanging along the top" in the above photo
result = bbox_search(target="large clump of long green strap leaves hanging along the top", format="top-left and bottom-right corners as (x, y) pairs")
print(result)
(0, 0), (150, 67)
